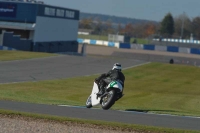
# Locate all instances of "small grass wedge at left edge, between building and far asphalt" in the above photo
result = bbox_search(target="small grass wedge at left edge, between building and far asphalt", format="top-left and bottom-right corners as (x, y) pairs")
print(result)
(0, 50), (56, 61)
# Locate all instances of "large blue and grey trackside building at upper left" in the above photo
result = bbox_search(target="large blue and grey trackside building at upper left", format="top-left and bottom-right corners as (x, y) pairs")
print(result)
(0, 0), (80, 52)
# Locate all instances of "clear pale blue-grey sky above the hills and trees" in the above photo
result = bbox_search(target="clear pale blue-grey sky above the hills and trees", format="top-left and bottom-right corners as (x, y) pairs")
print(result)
(43, 0), (200, 21)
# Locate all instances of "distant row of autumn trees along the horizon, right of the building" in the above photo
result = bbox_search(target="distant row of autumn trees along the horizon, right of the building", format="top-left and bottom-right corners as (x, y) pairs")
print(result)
(79, 13), (200, 39)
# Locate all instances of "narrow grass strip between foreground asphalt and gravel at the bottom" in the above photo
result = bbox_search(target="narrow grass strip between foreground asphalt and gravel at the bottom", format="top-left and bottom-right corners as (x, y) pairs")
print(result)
(0, 110), (200, 133)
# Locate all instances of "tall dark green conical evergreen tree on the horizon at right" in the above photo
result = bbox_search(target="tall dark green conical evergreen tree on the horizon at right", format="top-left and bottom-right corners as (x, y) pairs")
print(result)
(160, 13), (174, 37)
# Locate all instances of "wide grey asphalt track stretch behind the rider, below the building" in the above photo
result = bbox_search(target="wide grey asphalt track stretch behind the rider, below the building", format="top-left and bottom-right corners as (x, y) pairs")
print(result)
(0, 55), (145, 83)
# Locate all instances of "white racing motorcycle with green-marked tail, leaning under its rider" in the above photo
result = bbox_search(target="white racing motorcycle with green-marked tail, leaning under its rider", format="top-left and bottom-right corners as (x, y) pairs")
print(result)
(86, 81), (123, 110)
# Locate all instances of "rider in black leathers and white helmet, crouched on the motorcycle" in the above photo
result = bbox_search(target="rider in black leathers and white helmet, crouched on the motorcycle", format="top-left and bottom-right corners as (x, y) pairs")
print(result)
(95, 63), (125, 96)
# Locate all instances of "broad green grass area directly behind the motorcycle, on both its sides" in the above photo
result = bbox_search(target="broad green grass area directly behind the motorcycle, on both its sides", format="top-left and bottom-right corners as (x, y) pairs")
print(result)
(0, 63), (200, 116)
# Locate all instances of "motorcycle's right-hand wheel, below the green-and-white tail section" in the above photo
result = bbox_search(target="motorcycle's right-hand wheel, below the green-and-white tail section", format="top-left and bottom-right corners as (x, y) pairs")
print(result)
(101, 90), (116, 110)
